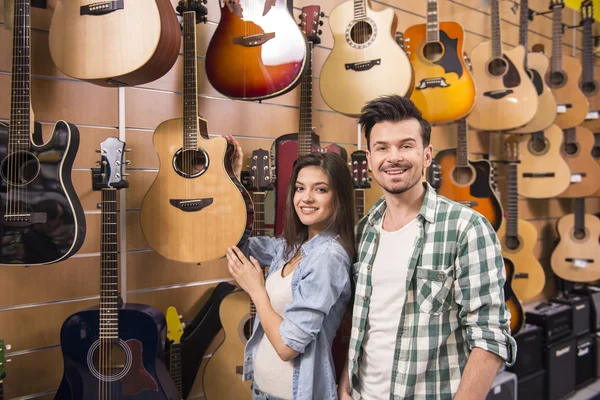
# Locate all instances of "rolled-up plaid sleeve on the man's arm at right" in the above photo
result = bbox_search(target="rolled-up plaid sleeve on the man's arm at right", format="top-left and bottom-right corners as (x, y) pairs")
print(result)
(454, 217), (517, 365)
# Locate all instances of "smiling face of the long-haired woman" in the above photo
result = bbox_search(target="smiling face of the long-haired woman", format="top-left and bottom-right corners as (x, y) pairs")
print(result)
(294, 166), (334, 234)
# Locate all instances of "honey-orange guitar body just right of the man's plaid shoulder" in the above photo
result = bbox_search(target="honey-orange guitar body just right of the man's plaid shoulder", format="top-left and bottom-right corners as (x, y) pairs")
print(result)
(498, 219), (546, 301)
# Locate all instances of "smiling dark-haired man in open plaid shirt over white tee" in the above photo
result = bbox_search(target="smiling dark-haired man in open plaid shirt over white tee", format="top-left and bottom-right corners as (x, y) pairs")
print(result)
(339, 96), (516, 400)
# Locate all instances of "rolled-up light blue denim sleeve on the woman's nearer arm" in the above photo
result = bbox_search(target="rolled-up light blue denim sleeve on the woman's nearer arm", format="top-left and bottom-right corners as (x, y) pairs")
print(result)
(279, 246), (351, 353)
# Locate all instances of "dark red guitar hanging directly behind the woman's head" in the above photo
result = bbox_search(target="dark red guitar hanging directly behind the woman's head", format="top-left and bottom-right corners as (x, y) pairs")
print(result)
(271, 6), (348, 236)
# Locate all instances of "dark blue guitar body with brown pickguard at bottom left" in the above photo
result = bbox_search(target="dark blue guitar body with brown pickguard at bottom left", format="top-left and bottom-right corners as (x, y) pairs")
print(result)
(54, 304), (177, 400)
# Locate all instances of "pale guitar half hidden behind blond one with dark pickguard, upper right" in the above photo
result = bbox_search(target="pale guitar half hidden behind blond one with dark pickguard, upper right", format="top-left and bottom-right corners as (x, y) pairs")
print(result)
(510, 0), (556, 133)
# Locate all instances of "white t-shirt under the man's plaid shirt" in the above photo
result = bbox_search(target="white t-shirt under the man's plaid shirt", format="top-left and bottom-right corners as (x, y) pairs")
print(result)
(358, 219), (420, 400)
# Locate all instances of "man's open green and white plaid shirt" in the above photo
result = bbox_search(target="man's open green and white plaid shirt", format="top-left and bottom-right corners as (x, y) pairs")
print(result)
(349, 183), (517, 400)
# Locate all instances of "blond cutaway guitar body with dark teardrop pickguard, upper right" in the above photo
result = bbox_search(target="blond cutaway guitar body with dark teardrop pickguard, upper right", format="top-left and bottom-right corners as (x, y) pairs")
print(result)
(469, 42), (538, 131)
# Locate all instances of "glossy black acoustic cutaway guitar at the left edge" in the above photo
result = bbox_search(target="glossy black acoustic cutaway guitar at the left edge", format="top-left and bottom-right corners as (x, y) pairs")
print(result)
(0, 0), (86, 266)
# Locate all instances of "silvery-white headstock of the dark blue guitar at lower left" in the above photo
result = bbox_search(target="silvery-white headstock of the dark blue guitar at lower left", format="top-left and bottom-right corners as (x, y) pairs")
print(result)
(92, 137), (131, 190)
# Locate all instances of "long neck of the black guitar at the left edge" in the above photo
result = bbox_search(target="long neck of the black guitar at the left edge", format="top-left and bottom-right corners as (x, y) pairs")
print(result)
(8, 0), (31, 152)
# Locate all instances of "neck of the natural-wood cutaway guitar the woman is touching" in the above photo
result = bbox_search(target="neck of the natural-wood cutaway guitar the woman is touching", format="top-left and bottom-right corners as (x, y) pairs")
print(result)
(183, 11), (198, 150)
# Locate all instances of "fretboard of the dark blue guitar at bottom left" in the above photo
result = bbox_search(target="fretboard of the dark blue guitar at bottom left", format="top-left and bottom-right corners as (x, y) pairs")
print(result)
(100, 189), (119, 340)
